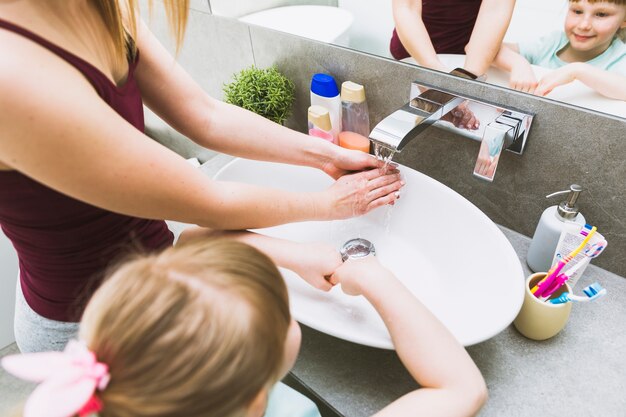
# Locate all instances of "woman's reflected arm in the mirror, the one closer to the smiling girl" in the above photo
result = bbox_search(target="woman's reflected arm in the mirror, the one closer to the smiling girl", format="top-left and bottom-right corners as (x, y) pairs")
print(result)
(464, 0), (515, 75)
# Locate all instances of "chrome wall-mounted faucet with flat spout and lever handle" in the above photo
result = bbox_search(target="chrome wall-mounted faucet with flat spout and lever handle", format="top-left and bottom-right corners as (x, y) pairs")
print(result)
(370, 82), (533, 181)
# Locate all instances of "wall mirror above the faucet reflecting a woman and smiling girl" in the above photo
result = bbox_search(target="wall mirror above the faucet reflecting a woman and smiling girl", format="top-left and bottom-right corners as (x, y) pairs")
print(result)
(209, 0), (626, 117)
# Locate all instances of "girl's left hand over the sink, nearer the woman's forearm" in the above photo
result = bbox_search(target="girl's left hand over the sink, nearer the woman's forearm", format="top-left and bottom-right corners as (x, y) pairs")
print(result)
(289, 243), (342, 291)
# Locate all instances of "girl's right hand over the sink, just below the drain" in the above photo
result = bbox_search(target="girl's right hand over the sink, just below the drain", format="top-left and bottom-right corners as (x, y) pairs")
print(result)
(330, 255), (394, 295)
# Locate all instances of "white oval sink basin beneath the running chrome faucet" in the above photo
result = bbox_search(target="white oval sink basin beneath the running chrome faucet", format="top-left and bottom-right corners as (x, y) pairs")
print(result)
(215, 159), (524, 349)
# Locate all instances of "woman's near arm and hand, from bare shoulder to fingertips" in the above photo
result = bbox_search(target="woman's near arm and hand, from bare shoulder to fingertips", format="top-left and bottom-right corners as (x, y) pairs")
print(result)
(0, 38), (400, 229)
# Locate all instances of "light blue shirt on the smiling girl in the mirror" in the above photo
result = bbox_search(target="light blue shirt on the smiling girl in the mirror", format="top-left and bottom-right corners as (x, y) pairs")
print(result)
(518, 30), (626, 76)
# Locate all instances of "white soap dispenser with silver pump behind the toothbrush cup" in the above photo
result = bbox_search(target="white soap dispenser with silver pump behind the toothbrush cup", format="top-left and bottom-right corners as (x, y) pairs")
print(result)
(526, 184), (585, 272)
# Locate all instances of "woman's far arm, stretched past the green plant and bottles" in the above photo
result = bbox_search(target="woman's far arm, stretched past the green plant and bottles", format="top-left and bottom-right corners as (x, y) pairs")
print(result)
(136, 22), (379, 178)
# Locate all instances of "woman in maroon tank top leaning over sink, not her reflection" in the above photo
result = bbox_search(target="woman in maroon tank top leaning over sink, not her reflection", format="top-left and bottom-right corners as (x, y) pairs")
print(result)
(0, 0), (400, 351)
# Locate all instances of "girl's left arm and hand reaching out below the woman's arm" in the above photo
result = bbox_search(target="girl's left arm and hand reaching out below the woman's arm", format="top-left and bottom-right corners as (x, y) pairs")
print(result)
(177, 226), (341, 291)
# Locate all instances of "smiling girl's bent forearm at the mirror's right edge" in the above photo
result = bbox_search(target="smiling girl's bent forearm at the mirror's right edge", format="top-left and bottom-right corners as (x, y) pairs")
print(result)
(535, 62), (626, 100)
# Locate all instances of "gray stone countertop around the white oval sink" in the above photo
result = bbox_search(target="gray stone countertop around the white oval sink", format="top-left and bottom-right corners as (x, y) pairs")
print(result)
(201, 155), (626, 417)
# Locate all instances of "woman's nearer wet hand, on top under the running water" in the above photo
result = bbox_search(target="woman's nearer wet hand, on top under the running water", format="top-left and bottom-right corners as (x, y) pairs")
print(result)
(323, 168), (404, 220)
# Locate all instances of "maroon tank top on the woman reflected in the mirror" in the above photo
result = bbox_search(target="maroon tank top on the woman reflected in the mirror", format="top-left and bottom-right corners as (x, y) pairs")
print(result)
(389, 0), (482, 59)
